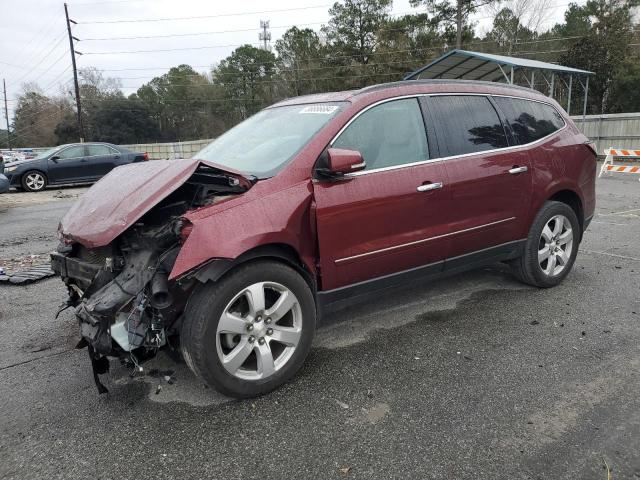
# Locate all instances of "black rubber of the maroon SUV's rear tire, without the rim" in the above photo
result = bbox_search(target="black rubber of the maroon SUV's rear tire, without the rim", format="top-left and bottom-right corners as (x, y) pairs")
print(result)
(511, 201), (582, 288)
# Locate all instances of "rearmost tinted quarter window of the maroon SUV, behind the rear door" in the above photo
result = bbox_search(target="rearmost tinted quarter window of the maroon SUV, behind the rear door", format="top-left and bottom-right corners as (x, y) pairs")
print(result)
(494, 97), (564, 145)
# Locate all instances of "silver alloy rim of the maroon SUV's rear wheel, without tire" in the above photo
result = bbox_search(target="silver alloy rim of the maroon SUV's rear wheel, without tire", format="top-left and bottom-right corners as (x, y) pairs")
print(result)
(538, 215), (573, 277)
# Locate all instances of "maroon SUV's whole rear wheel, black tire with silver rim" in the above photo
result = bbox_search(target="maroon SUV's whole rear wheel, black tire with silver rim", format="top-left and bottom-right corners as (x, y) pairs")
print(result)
(511, 201), (580, 288)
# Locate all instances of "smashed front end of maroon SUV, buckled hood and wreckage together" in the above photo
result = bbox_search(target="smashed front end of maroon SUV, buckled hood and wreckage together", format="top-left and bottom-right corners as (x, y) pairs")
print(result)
(51, 160), (253, 392)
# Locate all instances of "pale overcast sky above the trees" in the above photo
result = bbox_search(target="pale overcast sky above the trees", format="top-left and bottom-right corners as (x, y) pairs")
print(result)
(0, 0), (584, 122)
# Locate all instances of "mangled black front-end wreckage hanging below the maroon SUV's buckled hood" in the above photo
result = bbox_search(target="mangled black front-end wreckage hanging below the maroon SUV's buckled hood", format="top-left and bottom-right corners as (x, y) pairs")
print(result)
(51, 225), (188, 393)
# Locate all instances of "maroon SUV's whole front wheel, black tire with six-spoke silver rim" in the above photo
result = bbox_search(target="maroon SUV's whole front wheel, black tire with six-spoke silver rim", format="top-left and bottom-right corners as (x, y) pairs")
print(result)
(180, 261), (316, 398)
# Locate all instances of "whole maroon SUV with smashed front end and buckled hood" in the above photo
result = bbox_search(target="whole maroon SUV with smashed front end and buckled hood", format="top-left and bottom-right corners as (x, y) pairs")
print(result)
(52, 81), (596, 397)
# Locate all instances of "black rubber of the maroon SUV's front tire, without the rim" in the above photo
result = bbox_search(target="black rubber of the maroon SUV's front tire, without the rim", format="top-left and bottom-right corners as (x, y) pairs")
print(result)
(180, 260), (316, 398)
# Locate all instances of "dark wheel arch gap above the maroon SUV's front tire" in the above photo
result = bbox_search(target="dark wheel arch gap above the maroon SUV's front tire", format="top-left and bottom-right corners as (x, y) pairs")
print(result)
(194, 243), (317, 294)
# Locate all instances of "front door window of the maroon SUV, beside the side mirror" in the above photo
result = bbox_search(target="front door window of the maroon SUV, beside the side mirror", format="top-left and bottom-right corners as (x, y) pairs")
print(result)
(332, 98), (429, 170)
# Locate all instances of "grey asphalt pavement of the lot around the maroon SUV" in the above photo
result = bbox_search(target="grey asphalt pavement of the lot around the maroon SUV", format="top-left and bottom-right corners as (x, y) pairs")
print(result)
(0, 176), (640, 480)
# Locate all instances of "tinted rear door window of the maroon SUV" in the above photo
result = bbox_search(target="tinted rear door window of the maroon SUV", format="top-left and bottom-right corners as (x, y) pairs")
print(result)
(429, 95), (507, 157)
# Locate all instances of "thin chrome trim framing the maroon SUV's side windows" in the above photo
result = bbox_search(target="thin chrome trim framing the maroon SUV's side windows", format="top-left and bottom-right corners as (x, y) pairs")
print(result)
(329, 92), (568, 178)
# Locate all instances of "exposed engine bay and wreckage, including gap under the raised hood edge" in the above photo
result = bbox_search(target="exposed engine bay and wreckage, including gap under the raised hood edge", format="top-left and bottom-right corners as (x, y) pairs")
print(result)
(51, 164), (247, 393)
